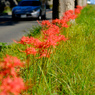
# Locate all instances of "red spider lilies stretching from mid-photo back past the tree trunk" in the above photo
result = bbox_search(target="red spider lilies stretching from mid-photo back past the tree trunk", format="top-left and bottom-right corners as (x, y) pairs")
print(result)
(14, 6), (82, 57)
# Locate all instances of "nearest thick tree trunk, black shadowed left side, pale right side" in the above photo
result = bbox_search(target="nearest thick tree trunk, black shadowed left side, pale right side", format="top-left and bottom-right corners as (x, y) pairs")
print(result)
(52, 0), (75, 19)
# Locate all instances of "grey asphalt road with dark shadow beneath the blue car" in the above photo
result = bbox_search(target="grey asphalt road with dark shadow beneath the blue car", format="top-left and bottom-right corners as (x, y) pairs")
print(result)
(0, 10), (52, 44)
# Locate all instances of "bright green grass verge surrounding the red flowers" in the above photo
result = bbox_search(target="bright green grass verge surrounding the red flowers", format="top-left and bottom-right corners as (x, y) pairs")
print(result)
(0, 5), (95, 95)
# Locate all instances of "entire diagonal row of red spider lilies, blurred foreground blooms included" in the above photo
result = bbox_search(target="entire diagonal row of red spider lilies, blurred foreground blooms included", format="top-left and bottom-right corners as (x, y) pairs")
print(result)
(0, 6), (82, 95)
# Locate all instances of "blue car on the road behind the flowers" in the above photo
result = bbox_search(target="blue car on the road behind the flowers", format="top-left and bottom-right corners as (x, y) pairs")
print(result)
(12, 0), (46, 20)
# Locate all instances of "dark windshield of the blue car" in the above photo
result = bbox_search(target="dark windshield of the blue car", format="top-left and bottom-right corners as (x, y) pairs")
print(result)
(19, 1), (40, 6)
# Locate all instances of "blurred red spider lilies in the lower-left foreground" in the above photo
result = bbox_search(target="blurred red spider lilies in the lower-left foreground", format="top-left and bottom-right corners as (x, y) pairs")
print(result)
(0, 55), (25, 95)
